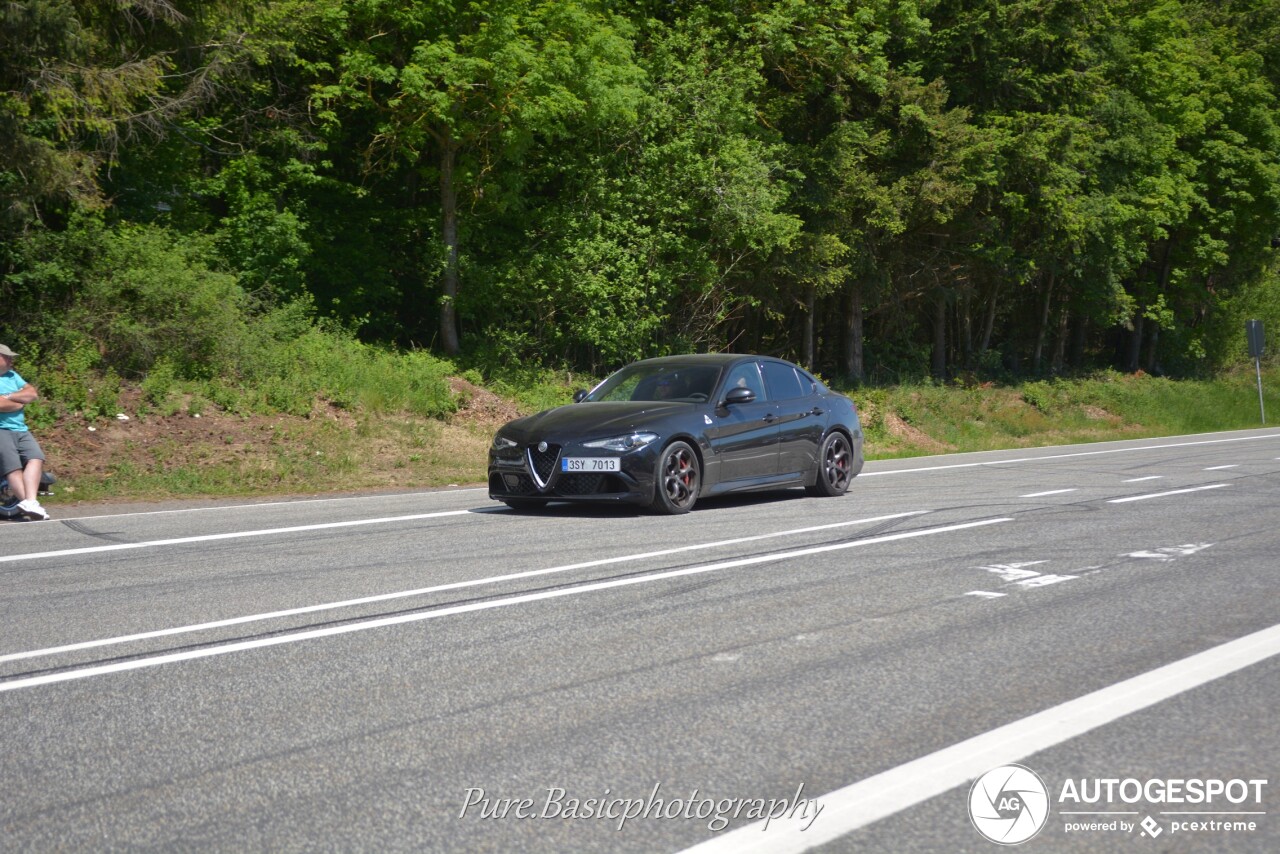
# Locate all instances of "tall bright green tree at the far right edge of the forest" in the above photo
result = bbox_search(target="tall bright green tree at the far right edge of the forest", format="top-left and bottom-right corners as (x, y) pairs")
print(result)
(1108, 1), (1280, 370)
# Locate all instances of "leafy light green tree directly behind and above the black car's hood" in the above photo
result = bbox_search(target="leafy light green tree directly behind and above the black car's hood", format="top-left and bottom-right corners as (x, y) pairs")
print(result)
(462, 10), (797, 370)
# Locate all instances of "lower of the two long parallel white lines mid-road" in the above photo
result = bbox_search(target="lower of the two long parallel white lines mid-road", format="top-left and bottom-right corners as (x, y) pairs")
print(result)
(0, 517), (1012, 691)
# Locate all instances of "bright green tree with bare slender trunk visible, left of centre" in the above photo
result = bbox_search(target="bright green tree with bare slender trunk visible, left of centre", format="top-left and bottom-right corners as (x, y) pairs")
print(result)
(316, 0), (640, 355)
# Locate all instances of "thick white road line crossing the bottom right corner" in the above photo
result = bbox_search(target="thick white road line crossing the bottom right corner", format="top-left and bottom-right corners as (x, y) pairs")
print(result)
(682, 625), (1280, 854)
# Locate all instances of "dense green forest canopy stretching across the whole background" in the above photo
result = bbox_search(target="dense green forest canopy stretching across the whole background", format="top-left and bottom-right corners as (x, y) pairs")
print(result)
(0, 0), (1280, 382)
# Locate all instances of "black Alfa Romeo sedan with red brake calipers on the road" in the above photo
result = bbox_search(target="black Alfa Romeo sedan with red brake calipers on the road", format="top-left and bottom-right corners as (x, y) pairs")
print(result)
(489, 353), (863, 513)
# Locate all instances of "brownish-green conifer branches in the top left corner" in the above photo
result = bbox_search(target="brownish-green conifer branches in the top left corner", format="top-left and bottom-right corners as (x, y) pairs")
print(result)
(0, 0), (257, 229)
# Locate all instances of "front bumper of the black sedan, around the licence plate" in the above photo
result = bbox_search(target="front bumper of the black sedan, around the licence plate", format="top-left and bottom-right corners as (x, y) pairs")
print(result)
(489, 443), (658, 504)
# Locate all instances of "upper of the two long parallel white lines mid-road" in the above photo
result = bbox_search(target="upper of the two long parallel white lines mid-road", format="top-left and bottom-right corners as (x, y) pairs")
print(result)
(0, 510), (925, 663)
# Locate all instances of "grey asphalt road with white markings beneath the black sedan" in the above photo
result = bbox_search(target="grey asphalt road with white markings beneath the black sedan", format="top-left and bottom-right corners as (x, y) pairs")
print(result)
(0, 430), (1280, 853)
